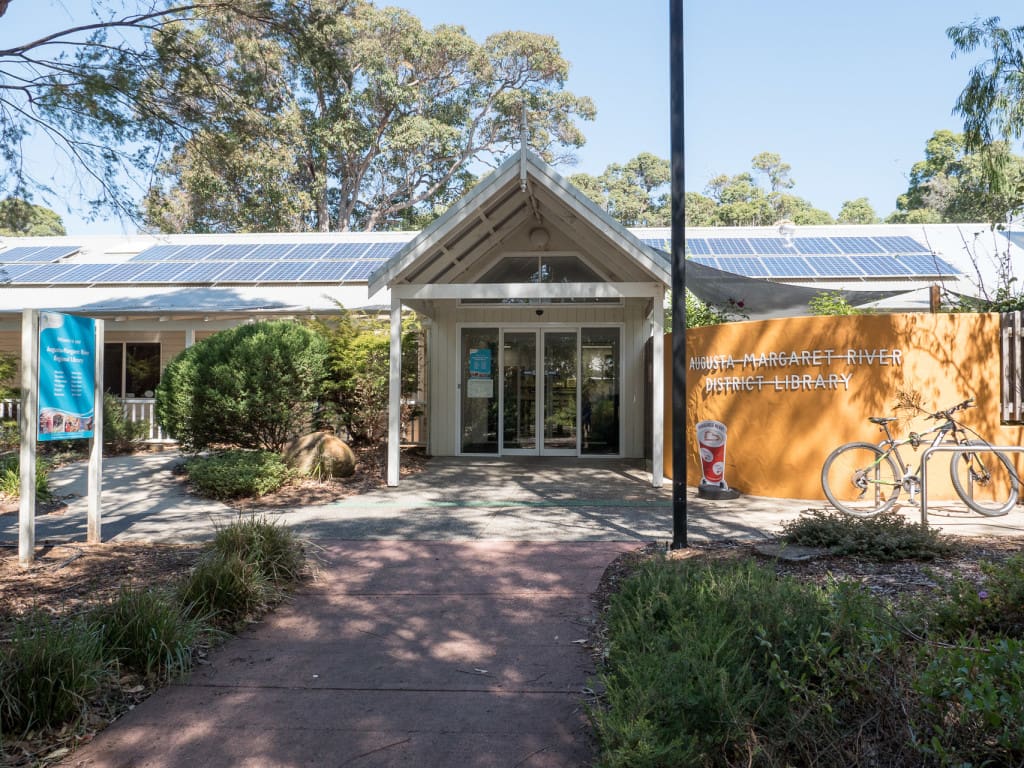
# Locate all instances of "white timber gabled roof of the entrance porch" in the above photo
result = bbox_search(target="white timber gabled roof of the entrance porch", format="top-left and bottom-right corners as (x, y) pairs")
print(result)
(369, 150), (672, 296)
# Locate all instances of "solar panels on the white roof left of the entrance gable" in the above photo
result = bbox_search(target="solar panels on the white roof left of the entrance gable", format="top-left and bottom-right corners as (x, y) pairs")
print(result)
(0, 242), (404, 285)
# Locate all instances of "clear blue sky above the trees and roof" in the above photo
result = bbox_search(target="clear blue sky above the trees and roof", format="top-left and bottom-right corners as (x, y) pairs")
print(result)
(0, 0), (1024, 233)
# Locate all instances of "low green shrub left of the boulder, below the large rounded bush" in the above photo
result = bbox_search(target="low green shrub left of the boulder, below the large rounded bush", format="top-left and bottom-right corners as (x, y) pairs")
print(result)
(185, 451), (294, 500)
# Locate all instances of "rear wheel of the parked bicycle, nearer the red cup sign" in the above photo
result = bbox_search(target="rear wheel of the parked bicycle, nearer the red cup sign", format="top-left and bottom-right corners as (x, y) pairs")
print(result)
(821, 442), (901, 517)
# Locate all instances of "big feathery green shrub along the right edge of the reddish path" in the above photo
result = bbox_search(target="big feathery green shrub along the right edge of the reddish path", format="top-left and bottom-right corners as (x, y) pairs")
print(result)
(591, 560), (897, 768)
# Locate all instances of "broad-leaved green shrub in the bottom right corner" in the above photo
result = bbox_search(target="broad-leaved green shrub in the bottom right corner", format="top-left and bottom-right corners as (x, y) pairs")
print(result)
(913, 637), (1024, 766)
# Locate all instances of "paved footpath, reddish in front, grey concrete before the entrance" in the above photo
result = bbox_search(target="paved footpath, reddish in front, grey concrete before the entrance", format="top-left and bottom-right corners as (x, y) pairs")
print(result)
(0, 454), (1024, 768)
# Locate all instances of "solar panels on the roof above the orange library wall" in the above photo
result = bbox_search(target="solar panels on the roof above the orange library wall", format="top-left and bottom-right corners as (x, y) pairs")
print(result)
(644, 236), (959, 280)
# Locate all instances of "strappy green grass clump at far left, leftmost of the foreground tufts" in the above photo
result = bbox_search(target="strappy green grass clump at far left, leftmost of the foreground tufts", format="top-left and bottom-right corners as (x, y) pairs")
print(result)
(0, 612), (108, 736)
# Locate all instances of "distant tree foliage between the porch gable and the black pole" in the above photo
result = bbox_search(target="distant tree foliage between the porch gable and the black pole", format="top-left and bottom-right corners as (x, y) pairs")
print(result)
(569, 152), (672, 226)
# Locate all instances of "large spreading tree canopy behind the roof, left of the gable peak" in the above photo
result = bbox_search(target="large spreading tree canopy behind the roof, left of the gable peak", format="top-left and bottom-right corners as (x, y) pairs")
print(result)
(141, 0), (596, 231)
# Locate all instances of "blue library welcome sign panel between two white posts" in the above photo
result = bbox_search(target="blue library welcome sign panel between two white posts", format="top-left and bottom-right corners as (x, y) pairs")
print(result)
(39, 312), (96, 440)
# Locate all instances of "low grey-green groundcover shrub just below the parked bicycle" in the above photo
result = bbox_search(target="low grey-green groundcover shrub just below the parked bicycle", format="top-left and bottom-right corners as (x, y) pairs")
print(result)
(782, 509), (955, 562)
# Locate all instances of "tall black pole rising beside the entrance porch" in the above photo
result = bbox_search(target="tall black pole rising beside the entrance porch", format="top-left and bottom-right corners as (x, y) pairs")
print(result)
(669, 0), (687, 549)
